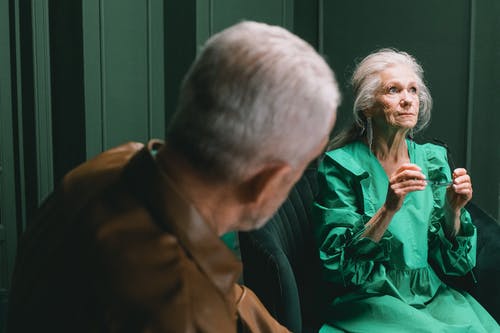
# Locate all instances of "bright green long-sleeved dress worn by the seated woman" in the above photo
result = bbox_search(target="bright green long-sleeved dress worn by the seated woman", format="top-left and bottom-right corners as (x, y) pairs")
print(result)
(313, 140), (500, 333)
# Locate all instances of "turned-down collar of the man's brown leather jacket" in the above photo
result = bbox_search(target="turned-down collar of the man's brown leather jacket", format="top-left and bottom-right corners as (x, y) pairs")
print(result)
(119, 140), (242, 297)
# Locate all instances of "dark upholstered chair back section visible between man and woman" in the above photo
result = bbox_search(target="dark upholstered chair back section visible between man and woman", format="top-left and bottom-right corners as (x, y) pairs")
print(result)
(239, 168), (324, 332)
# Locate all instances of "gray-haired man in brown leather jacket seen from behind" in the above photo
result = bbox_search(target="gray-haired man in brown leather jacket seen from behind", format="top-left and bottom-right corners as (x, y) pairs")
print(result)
(8, 22), (339, 333)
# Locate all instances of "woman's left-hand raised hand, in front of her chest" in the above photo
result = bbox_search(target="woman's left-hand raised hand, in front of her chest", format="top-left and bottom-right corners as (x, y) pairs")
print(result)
(385, 163), (427, 212)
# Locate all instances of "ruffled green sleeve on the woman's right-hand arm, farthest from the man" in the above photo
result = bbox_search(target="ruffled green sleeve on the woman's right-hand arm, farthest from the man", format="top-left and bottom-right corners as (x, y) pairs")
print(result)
(426, 145), (477, 276)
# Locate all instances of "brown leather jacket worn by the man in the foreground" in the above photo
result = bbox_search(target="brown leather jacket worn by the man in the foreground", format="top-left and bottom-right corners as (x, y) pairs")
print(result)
(8, 143), (286, 333)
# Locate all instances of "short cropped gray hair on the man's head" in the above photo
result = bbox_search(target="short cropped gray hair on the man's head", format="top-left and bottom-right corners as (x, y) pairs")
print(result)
(167, 22), (340, 179)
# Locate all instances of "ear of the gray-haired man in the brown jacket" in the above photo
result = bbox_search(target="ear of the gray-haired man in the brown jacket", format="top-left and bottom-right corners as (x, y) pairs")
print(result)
(239, 162), (292, 206)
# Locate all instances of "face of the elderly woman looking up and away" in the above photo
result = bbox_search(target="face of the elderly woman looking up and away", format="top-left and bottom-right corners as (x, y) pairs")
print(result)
(367, 65), (420, 129)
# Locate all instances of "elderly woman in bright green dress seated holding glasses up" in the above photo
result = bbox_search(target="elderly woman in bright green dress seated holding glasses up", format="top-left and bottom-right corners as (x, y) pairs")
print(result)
(314, 49), (500, 333)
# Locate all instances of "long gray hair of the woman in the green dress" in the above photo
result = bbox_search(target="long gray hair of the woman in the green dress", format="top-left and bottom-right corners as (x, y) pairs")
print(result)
(329, 48), (432, 149)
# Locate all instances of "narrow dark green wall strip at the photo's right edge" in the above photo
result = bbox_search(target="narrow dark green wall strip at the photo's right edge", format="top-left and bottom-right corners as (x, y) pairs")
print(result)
(468, 0), (500, 221)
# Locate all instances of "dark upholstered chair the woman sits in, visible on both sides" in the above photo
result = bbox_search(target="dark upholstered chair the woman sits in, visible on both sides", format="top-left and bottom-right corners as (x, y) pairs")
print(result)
(239, 167), (500, 332)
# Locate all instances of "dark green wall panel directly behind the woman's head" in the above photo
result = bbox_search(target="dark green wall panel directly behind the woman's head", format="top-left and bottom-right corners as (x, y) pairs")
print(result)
(323, 0), (470, 161)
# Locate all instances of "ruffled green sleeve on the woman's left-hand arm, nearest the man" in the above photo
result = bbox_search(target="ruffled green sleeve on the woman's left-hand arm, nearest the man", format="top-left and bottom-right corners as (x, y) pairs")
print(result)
(313, 153), (398, 286)
